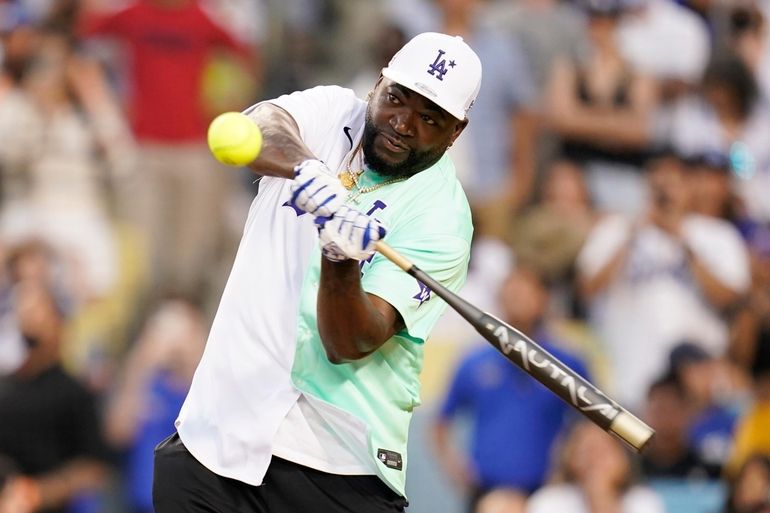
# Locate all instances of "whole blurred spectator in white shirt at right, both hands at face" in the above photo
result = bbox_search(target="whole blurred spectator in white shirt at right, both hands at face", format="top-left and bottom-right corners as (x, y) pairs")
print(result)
(577, 150), (749, 407)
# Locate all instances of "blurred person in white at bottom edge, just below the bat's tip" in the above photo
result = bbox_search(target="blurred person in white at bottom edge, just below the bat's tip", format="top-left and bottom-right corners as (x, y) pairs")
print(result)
(527, 421), (664, 513)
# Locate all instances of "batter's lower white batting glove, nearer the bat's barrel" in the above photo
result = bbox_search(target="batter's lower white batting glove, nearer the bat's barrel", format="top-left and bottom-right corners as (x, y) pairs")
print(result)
(316, 205), (386, 262)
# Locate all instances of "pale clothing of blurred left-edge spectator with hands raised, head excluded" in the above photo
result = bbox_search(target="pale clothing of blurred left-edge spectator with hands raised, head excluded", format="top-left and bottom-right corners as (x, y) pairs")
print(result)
(0, 93), (118, 298)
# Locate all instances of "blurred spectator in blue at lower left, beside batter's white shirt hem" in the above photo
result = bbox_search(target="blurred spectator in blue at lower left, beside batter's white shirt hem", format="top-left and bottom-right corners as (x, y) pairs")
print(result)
(106, 299), (206, 513)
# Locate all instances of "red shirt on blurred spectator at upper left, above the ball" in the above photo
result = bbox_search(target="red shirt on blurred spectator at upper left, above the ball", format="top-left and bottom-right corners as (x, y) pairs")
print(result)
(80, 0), (249, 143)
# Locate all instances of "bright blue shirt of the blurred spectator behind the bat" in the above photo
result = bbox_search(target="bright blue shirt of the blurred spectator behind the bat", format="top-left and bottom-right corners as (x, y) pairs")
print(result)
(432, 330), (587, 493)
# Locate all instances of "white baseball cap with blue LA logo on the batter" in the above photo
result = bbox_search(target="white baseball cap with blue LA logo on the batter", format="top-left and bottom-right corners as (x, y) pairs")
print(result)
(382, 32), (481, 120)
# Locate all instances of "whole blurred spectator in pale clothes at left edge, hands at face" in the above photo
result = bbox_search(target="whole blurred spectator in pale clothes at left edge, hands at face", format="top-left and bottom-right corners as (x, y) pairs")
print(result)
(0, 34), (131, 304)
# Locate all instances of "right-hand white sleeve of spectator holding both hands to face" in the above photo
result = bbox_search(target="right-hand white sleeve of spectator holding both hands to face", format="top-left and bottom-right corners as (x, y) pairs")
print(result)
(683, 218), (751, 292)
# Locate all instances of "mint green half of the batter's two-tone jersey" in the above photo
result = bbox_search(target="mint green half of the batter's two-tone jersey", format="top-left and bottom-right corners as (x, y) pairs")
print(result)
(292, 155), (473, 495)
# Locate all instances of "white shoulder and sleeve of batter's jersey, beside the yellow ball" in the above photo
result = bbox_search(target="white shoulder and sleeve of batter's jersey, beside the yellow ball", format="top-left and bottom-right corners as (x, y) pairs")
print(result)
(246, 86), (363, 160)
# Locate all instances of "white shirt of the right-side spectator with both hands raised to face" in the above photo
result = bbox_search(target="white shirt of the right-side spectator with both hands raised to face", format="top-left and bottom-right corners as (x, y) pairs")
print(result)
(580, 215), (750, 406)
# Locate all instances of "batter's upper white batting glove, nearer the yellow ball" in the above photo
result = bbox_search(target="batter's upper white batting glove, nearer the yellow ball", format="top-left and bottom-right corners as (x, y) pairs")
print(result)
(289, 159), (348, 218)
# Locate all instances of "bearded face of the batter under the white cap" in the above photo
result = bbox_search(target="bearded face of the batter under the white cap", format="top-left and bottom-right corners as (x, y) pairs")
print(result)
(363, 78), (467, 176)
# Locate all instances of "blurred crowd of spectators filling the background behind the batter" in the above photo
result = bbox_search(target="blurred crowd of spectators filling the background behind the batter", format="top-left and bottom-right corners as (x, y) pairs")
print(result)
(0, 0), (770, 513)
